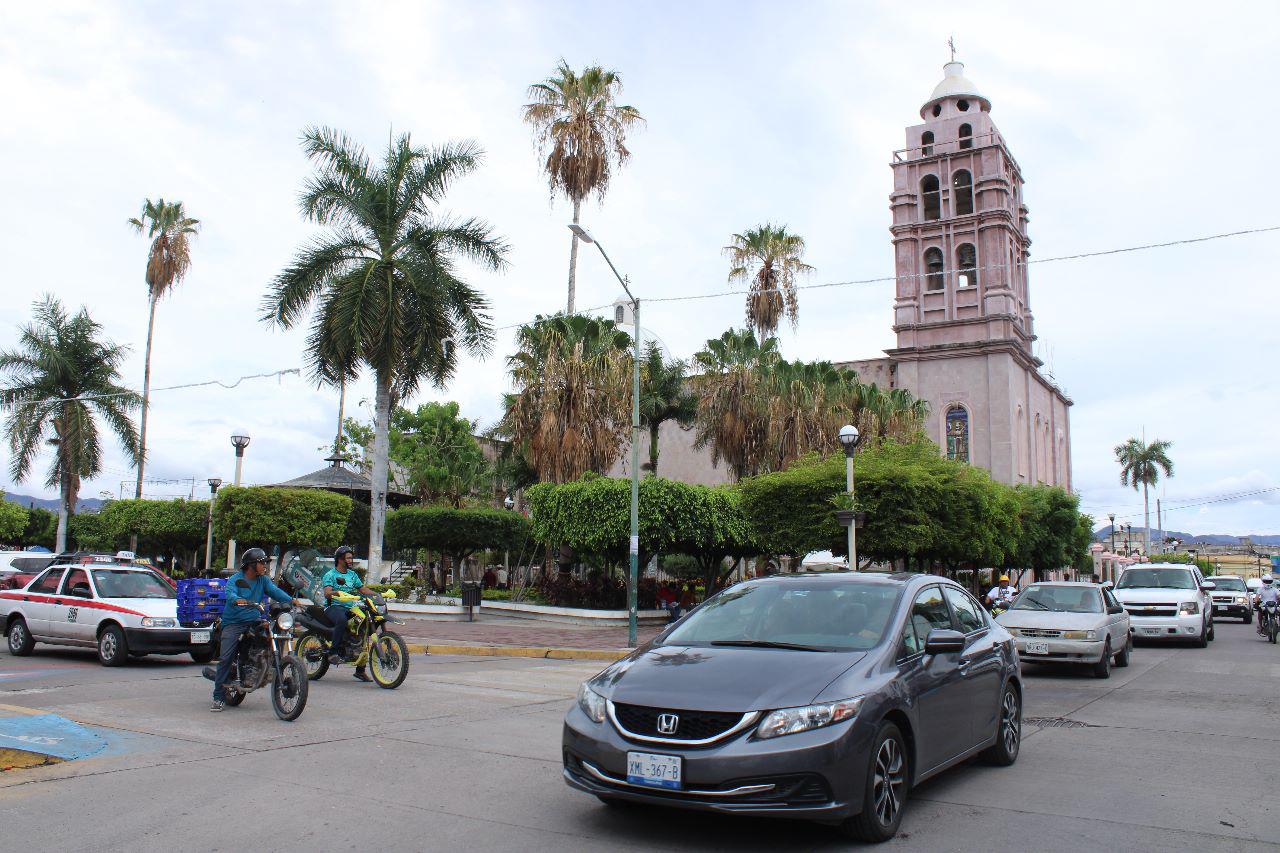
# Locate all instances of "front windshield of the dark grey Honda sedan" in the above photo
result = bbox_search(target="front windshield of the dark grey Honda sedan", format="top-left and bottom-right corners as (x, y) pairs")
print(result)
(663, 580), (900, 652)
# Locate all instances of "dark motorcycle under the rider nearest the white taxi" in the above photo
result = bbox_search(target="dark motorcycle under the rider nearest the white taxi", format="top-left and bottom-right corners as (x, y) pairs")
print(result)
(202, 605), (308, 722)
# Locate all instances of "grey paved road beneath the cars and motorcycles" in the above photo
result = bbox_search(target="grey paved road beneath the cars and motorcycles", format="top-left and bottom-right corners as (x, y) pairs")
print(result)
(0, 614), (1280, 853)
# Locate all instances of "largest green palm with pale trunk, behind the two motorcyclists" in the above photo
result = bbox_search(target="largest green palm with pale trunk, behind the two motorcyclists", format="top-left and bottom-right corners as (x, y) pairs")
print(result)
(262, 128), (507, 578)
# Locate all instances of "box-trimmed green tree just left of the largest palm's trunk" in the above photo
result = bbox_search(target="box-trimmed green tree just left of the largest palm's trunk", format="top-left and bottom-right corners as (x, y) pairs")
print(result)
(214, 485), (355, 558)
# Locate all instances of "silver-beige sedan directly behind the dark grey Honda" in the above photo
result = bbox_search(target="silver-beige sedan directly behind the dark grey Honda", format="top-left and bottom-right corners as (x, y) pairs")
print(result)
(996, 581), (1133, 679)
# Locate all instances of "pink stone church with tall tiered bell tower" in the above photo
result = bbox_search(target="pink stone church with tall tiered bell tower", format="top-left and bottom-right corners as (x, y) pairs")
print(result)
(613, 61), (1071, 489)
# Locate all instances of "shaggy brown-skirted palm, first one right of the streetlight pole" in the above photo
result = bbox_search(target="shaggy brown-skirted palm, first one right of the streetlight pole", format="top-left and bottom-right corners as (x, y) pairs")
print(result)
(691, 329), (778, 479)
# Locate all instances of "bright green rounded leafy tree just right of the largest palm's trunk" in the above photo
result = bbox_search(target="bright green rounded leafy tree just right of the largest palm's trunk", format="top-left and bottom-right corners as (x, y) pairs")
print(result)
(390, 402), (493, 507)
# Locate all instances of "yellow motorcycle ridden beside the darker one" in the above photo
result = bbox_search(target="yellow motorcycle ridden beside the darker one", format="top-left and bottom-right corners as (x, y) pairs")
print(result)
(298, 590), (408, 690)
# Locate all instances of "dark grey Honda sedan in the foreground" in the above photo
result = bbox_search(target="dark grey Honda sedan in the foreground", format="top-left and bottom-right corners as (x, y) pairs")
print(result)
(563, 573), (1023, 841)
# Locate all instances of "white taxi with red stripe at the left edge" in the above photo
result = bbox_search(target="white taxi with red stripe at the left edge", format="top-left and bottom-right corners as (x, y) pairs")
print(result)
(0, 562), (214, 666)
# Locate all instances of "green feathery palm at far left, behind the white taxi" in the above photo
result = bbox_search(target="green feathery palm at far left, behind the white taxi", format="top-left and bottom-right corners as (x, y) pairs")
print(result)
(0, 296), (142, 552)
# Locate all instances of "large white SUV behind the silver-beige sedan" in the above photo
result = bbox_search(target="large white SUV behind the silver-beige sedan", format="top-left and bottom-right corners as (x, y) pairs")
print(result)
(1115, 562), (1213, 648)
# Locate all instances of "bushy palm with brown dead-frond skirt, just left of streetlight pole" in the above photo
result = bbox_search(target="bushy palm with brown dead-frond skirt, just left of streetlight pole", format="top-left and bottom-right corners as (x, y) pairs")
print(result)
(502, 315), (631, 483)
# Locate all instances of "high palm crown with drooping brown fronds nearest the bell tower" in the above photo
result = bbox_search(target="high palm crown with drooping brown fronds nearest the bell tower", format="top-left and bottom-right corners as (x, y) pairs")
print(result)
(724, 223), (813, 341)
